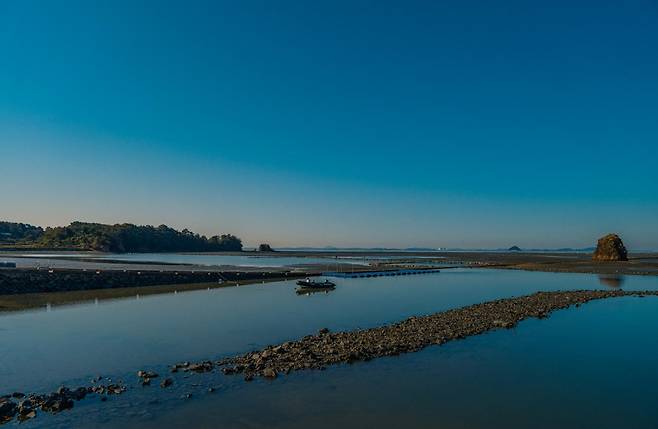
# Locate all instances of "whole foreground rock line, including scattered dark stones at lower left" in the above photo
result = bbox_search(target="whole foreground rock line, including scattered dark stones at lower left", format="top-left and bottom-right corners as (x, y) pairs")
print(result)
(0, 290), (658, 424)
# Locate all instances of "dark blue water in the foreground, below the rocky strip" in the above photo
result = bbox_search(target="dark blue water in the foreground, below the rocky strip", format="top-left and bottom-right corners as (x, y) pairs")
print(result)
(120, 298), (658, 429)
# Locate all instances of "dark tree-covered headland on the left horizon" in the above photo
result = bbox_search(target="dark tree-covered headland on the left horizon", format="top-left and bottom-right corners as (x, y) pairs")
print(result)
(0, 221), (242, 253)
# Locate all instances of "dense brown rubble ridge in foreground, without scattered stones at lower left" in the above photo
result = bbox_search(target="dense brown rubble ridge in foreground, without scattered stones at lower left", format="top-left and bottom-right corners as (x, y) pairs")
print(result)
(218, 290), (658, 380)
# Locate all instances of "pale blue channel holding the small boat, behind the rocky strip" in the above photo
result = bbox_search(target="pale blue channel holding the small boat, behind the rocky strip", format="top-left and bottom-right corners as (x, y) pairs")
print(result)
(0, 269), (658, 394)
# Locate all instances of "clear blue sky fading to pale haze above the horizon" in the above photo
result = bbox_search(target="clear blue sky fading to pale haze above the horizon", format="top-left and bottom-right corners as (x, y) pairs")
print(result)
(0, 0), (658, 249)
